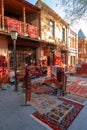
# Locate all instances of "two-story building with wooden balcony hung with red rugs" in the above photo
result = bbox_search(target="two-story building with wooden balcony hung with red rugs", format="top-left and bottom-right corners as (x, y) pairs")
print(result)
(0, 0), (41, 67)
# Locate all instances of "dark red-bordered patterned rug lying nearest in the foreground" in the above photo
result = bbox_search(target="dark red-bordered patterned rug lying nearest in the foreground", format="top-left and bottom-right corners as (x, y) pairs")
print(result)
(32, 98), (83, 130)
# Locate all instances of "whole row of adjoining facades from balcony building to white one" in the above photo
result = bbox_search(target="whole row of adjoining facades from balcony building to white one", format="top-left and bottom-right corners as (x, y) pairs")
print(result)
(0, 0), (77, 67)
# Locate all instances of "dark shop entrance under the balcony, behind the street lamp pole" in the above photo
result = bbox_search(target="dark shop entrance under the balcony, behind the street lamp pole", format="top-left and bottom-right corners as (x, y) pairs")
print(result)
(9, 46), (36, 67)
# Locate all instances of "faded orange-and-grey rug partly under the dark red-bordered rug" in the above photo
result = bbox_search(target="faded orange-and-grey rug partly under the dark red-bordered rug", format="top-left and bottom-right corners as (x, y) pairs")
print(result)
(31, 94), (60, 114)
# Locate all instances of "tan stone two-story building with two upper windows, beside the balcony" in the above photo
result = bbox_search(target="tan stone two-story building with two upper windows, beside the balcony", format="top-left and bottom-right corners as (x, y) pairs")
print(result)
(36, 0), (69, 66)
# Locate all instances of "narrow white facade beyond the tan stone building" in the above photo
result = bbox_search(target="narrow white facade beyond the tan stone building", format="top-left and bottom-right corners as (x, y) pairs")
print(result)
(68, 27), (78, 67)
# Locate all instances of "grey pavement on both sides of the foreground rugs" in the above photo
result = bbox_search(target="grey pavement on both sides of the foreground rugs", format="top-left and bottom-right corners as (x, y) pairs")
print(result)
(0, 81), (87, 130)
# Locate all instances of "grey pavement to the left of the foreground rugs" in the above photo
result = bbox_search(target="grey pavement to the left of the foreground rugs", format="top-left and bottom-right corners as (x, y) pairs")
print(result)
(0, 87), (47, 130)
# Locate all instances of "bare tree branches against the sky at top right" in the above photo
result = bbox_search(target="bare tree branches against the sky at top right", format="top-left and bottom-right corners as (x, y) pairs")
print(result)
(57, 0), (87, 22)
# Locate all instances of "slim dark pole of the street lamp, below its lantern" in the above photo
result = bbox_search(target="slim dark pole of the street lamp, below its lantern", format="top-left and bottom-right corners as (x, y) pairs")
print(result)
(13, 40), (18, 91)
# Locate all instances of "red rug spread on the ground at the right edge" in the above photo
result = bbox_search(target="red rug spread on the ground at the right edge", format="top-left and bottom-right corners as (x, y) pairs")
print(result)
(66, 80), (87, 98)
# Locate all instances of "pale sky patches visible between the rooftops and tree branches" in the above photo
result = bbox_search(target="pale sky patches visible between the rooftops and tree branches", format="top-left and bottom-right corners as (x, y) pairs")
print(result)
(27, 0), (87, 37)
